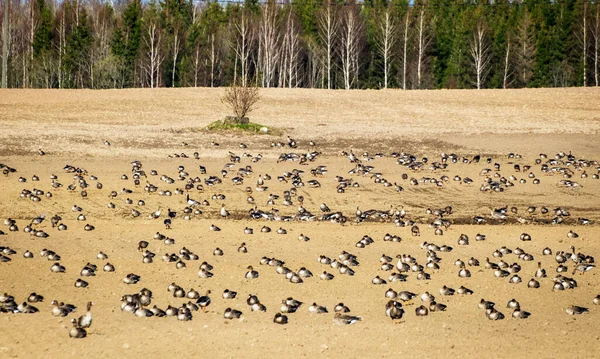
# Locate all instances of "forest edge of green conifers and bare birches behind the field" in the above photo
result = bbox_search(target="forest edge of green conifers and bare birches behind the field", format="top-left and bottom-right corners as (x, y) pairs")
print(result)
(0, 0), (600, 89)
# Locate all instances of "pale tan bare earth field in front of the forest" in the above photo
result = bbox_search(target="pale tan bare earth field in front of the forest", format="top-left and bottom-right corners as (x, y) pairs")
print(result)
(0, 89), (600, 358)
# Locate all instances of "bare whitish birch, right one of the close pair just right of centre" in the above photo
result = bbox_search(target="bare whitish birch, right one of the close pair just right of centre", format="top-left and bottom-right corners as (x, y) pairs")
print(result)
(339, 6), (362, 90)
